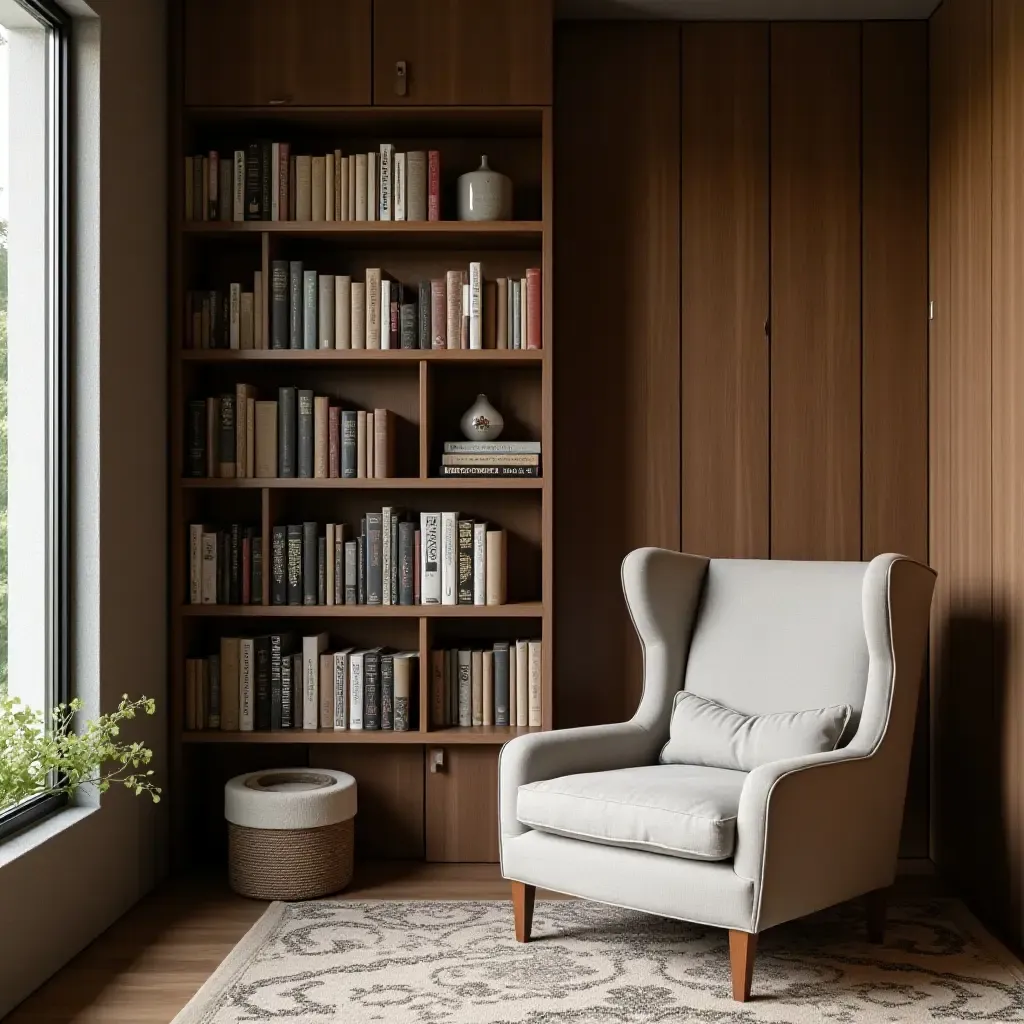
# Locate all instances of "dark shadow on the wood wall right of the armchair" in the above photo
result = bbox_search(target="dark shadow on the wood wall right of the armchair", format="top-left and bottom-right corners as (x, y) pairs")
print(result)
(933, 610), (1022, 948)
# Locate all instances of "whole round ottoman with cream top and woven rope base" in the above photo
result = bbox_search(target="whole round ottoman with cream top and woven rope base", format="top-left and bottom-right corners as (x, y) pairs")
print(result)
(224, 768), (355, 899)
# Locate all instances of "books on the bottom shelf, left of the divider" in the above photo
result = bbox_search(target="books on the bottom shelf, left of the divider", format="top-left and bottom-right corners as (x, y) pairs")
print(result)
(184, 633), (420, 732)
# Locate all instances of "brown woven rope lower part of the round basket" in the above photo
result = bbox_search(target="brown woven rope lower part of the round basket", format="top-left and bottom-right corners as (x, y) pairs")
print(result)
(227, 818), (355, 899)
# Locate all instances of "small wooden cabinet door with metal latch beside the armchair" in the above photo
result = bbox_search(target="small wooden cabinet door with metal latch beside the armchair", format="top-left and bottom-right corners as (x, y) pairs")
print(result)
(424, 745), (498, 863)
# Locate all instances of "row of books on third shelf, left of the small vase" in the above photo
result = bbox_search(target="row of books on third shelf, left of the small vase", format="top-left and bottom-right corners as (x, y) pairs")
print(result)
(185, 395), (396, 479)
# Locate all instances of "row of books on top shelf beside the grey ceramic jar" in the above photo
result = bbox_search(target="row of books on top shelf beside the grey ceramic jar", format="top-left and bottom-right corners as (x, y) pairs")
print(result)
(184, 139), (440, 221)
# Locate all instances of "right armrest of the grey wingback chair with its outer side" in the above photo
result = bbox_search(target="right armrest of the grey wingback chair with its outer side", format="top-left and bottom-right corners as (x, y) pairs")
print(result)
(734, 749), (905, 931)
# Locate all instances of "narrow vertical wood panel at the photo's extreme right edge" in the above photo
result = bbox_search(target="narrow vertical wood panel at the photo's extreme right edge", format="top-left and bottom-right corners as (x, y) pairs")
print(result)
(992, 0), (1024, 947)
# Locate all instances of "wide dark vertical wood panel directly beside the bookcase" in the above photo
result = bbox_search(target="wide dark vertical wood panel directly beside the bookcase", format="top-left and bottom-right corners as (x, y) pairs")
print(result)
(553, 24), (680, 726)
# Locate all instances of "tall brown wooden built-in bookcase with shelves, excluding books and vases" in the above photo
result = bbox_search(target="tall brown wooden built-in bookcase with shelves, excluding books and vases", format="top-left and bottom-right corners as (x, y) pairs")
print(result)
(168, 105), (554, 859)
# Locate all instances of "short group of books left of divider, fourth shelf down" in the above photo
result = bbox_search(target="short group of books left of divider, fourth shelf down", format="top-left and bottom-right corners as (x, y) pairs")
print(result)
(188, 523), (263, 604)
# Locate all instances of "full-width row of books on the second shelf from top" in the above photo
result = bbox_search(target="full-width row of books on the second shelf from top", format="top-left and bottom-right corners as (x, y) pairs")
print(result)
(184, 260), (543, 350)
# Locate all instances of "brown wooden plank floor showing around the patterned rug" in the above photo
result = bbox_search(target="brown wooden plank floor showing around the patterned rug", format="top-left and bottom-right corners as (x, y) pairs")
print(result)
(4, 862), (520, 1024)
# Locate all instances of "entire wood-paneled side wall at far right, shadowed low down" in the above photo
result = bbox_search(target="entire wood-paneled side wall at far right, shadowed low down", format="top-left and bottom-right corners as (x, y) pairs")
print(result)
(930, 0), (1024, 948)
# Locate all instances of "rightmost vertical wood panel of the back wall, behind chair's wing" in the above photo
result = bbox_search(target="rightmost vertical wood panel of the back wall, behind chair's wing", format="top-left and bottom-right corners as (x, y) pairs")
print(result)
(861, 22), (929, 857)
